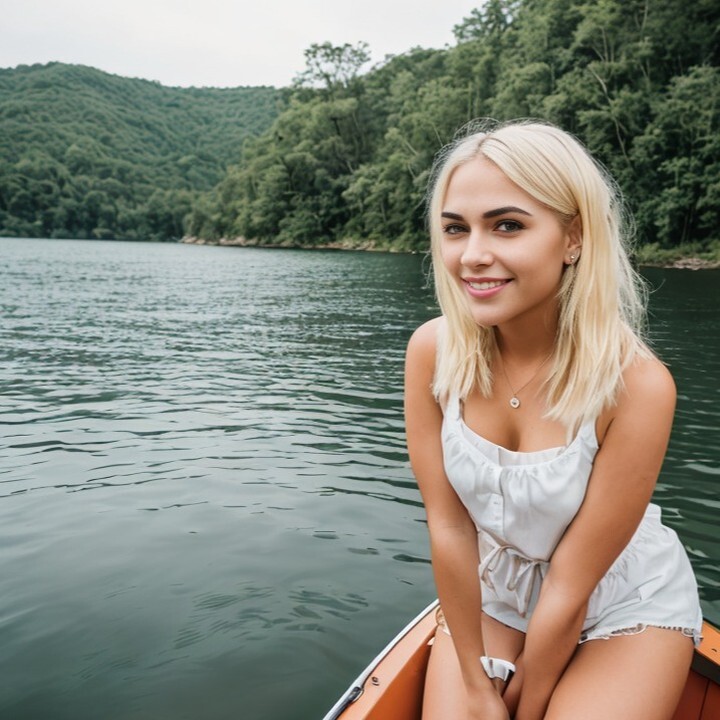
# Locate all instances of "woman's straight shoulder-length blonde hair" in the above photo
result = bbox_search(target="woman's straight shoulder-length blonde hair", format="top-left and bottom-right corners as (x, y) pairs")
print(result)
(428, 121), (651, 433)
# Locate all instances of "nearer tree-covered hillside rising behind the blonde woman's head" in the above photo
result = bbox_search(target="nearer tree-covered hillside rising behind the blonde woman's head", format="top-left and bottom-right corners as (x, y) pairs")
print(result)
(188, 0), (720, 252)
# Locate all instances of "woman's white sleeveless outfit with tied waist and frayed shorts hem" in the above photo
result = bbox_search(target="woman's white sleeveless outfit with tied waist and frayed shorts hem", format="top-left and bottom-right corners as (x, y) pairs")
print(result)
(442, 397), (702, 644)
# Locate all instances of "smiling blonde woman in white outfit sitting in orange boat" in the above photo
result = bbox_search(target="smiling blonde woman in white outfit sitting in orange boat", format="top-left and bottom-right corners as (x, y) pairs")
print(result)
(406, 123), (702, 720)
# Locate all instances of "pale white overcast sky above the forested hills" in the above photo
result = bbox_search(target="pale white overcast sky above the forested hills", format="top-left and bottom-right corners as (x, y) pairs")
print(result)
(0, 0), (482, 87)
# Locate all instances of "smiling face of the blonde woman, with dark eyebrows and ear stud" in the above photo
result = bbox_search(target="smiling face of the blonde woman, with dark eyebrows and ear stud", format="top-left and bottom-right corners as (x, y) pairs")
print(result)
(441, 157), (579, 329)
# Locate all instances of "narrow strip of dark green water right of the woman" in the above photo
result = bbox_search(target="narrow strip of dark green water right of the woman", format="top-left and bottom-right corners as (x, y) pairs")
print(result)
(646, 269), (720, 624)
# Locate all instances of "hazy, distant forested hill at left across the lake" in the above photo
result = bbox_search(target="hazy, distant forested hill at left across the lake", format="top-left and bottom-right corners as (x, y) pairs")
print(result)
(0, 63), (279, 240)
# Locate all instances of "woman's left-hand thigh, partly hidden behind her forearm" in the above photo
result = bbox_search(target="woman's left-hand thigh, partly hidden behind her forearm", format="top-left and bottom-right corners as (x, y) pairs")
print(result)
(423, 613), (525, 720)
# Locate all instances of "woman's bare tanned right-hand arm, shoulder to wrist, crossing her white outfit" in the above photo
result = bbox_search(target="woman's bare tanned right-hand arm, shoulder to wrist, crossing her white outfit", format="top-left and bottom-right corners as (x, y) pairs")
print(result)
(515, 358), (675, 720)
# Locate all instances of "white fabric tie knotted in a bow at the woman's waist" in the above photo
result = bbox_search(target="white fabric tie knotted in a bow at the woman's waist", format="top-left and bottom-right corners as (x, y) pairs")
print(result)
(478, 530), (548, 617)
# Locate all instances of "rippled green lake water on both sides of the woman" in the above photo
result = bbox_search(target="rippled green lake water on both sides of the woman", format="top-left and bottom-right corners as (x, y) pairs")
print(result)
(0, 239), (720, 720)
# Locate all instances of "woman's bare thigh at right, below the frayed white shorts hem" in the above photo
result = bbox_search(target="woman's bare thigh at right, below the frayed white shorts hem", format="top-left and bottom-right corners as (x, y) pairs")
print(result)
(545, 627), (693, 720)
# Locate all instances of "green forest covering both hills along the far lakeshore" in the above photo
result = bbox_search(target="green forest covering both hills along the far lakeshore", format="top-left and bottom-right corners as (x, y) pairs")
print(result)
(0, 0), (720, 250)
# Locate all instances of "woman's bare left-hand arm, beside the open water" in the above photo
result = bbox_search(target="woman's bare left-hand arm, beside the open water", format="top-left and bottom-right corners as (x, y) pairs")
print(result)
(405, 319), (507, 719)
